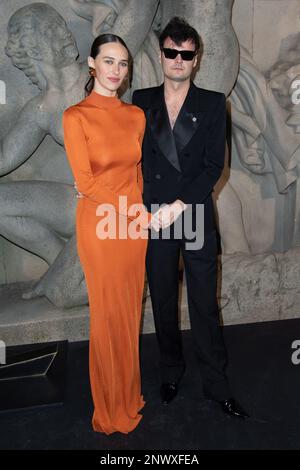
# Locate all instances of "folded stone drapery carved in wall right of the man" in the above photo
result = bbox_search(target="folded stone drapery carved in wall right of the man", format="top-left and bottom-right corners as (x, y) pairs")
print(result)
(231, 48), (300, 193)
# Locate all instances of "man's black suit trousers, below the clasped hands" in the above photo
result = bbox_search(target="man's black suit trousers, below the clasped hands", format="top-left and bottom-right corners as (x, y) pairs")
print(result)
(146, 230), (231, 400)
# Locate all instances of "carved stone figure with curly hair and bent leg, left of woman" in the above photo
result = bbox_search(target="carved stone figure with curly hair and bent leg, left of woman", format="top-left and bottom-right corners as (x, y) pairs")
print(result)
(0, 3), (88, 307)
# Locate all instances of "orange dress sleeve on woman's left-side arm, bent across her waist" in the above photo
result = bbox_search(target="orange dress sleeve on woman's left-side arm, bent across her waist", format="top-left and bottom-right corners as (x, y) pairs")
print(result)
(63, 108), (144, 219)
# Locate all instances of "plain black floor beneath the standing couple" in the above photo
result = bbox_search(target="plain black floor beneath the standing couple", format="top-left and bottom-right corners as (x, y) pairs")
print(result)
(0, 319), (300, 450)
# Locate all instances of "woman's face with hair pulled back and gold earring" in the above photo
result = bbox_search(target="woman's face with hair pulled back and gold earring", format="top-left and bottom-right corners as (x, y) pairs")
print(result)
(88, 42), (128, 96)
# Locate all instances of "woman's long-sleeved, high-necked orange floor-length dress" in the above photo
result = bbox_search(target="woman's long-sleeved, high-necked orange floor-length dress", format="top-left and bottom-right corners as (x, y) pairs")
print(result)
(63, 91), (150, 434)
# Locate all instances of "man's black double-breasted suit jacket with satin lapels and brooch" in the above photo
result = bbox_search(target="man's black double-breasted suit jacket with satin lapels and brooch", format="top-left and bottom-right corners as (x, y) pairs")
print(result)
(132, 82), (226, 231)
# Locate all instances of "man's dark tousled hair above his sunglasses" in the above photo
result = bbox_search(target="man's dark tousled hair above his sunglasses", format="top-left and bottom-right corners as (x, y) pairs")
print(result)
(159, 16), (201, 52)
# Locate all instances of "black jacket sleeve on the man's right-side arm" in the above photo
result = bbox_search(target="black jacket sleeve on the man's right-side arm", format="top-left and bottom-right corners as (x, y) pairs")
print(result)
(178, 94), (226, 204)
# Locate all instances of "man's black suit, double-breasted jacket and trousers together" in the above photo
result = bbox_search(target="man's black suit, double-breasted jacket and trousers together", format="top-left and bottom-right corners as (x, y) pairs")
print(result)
(133, 83), (230, 400)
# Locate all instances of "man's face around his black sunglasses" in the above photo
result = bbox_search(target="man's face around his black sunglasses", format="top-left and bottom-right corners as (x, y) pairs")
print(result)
(160, 37), (197, 82)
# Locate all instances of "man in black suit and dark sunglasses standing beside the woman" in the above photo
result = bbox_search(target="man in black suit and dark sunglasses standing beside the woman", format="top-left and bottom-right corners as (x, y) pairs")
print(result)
(133, 17), (248, 418)
